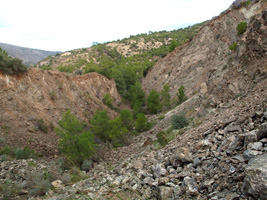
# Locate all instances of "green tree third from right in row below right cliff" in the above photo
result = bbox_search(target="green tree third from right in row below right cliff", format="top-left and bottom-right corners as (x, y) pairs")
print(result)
(147, 89), (162, 114)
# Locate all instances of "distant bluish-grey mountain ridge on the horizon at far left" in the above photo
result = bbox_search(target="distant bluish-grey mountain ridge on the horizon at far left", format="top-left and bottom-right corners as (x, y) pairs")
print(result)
(0, 43), (61, 66)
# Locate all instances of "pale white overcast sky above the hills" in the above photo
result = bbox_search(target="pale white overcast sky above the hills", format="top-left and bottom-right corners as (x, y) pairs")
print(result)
(0, 0), (233, 51)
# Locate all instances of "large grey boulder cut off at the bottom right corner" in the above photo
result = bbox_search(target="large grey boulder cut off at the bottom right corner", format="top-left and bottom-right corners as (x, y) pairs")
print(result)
(243, 153), (267, 200)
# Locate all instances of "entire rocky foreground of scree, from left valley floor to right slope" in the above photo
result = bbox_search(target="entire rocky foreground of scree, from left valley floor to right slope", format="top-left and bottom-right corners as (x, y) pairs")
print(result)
(0, 84), (267, 200)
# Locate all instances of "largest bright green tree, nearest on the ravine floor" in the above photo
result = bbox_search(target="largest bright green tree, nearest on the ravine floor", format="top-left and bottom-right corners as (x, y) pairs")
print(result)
(55, 110), (95, 166)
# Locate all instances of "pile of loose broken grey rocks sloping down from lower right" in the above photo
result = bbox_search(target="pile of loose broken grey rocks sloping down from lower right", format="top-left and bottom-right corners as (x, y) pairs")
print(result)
(34, 101), (267, 200)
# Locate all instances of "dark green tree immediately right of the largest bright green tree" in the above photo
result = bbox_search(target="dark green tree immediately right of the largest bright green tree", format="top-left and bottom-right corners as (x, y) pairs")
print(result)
(90, 110), (110, 141)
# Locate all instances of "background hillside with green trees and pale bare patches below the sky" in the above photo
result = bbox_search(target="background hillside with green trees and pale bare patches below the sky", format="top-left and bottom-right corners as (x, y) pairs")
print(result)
(37, 23), (204, 97)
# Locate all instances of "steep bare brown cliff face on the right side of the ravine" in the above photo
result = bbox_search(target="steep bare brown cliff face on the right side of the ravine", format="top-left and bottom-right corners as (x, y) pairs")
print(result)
(143, 2), (267, 103)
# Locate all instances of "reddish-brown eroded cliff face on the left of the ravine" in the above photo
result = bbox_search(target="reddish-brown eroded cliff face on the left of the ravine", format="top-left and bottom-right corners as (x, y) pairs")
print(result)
(0, 69), (121, 155)
